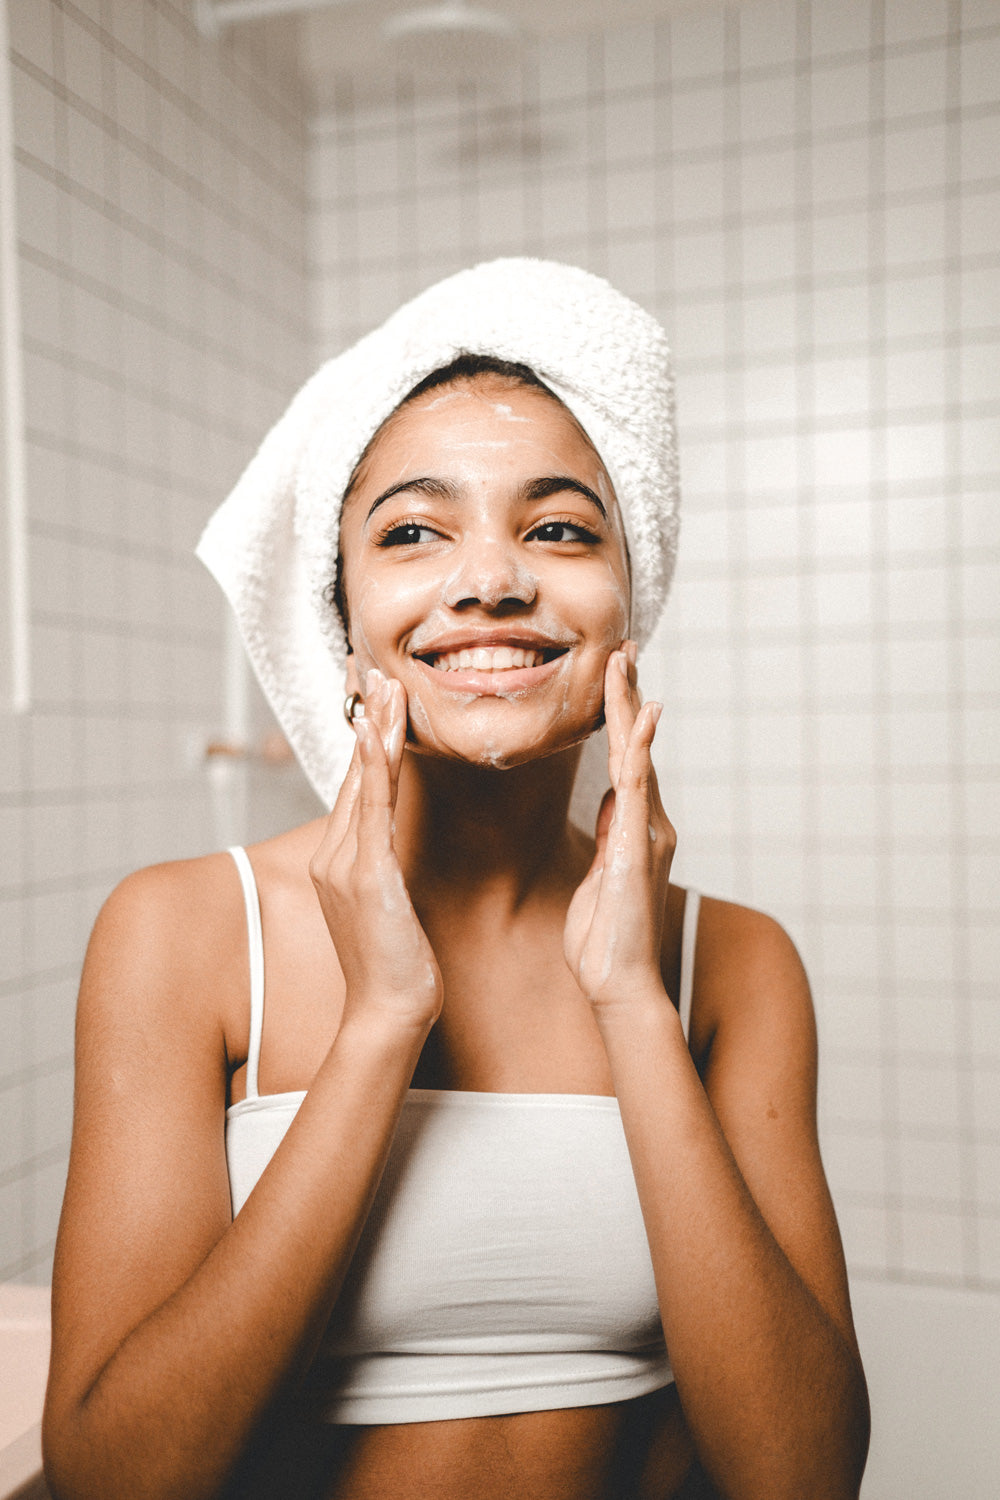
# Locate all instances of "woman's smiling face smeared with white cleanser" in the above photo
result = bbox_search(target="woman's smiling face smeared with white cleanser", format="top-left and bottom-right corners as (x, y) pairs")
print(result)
(340, 375), (628, 767)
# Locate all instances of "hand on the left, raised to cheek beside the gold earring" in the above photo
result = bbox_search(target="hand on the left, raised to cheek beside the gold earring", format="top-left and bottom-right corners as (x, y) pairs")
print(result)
(309, 669), (444, 1028)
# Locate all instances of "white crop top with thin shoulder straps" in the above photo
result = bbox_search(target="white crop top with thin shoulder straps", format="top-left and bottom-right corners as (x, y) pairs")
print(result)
(226, 849), (699, 1424)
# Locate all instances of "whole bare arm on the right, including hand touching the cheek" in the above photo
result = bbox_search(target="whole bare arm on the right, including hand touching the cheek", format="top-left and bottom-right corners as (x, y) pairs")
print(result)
(567, 651), (868, 1500)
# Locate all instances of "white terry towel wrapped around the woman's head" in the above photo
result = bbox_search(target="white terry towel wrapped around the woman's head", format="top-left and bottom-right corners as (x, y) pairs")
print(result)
(198, 260), (678, 806)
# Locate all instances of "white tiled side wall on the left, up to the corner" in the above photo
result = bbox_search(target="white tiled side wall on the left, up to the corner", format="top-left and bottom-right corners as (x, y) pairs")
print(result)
(0, 0), (310, 1281)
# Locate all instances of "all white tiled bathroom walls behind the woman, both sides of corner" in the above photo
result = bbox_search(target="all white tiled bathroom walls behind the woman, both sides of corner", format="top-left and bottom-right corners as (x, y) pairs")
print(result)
(0, 0), (1000, 1284)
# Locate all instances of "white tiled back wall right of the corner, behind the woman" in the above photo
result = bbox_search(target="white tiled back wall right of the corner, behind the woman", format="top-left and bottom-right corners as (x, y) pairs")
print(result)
(309, 0), (1000, 1286)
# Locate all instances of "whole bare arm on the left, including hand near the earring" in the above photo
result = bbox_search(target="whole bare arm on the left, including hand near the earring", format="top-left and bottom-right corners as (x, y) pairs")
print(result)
(43, 675), (441, 1500)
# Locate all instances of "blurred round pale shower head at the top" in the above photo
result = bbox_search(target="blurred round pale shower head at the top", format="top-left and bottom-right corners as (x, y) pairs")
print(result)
(382, 0), (522, 78)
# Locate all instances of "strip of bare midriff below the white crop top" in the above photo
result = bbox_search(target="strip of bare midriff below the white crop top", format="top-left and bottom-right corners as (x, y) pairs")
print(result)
(241, 1386), (694, 1500)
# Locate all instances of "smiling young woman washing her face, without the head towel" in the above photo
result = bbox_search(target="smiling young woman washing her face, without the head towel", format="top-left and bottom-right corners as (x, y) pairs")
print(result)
(43, 266), (868, 1500)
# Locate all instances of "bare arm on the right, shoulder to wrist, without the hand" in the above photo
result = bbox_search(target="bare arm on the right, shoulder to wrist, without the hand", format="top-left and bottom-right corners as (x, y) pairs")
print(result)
(601, 914), (868, 1500)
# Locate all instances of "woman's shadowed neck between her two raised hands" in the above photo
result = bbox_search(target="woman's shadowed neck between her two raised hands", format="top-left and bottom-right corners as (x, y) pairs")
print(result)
(396, 747), (580, 906)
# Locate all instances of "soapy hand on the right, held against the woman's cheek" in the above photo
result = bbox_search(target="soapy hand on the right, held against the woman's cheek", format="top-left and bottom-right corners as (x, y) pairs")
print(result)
(564, 642), (676, 1011)
